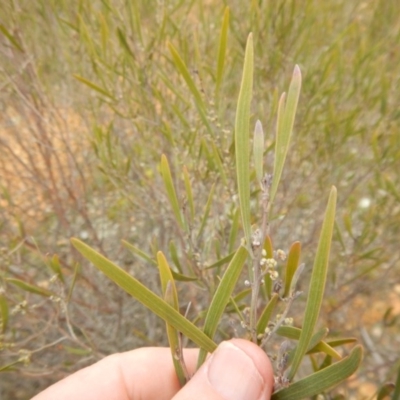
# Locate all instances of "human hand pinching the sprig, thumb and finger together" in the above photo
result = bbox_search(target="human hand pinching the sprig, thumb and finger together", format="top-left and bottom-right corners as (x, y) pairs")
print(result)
(32, 339), (273, 400)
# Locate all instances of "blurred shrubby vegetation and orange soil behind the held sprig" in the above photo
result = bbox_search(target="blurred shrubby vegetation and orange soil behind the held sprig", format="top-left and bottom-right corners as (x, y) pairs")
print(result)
(0, 0), (400, 399)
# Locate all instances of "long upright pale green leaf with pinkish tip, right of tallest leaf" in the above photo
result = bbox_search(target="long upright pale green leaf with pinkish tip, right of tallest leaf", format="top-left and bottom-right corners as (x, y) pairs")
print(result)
(270, 65), (301, 203)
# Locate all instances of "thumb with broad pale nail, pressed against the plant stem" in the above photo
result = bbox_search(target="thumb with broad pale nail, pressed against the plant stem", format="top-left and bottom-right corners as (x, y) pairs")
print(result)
(173, 339), (273, 400)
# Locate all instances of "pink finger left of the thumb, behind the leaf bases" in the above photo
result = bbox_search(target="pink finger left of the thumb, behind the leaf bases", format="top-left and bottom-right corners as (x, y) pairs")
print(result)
(32, 347), (198, 400)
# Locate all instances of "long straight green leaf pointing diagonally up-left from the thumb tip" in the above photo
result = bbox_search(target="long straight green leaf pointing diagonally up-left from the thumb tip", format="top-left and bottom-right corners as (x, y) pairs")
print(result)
(71, 238), (217, 352)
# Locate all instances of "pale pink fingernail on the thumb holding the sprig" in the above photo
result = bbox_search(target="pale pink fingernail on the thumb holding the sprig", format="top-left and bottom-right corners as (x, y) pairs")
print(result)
(207, 342), (264, 400)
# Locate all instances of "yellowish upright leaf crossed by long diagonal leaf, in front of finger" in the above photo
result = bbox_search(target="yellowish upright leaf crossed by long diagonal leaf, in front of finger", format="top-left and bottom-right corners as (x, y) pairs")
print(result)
(157, 251), (186, 386)
